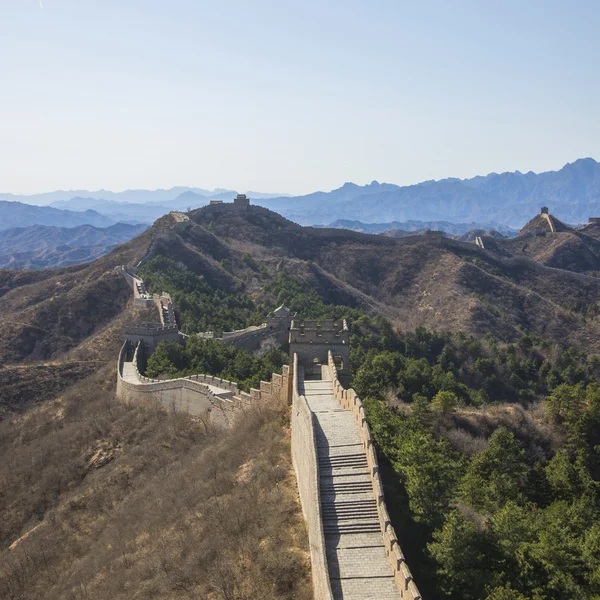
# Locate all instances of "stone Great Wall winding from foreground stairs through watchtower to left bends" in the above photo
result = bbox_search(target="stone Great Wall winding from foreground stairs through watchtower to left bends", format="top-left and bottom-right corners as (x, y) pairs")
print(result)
(117, 267), (421, 600)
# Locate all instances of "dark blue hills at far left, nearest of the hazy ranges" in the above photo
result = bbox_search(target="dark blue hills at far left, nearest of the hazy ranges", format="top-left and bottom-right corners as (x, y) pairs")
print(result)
(0, 223), (147, 269)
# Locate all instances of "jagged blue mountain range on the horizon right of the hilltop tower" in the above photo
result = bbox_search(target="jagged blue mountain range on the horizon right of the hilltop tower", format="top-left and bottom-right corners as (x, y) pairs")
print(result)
(258, 158), (600, 228)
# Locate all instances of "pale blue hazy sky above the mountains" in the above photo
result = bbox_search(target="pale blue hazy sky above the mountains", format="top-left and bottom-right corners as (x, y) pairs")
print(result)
(0, 0), (600, 193)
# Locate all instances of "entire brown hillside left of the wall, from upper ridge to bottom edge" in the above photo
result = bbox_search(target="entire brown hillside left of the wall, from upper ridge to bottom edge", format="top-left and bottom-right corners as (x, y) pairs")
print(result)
(0, 209), (312, 600)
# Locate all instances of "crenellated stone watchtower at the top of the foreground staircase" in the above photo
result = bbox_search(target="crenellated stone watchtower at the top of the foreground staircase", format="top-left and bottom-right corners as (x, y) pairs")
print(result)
(290, 319), (350, 376)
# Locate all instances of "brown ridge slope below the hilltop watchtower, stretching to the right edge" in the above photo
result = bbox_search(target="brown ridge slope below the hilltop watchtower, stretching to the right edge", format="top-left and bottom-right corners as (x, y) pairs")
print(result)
(168, 205), (600, 350)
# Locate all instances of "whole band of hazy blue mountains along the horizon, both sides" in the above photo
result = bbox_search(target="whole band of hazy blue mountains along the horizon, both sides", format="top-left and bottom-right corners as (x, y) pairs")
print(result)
(0, 158), (600, 235)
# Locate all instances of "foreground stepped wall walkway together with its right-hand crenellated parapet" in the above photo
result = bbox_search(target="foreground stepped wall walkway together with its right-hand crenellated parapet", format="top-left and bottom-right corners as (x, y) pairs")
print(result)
(298, 353), (421, 600)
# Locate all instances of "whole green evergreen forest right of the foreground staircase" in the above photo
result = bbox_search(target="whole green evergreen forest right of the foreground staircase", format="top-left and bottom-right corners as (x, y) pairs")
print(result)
(364, 330), (600, 600)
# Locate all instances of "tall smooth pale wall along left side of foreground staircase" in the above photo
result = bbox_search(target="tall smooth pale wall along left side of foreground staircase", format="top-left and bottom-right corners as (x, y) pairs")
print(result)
(292, 354), (333, 600)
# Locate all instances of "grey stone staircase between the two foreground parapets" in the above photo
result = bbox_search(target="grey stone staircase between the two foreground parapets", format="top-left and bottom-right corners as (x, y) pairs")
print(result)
(299, 367), (400, 600)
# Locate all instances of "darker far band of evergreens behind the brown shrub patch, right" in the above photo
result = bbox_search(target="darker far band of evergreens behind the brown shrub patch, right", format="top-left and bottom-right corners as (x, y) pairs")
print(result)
(351, 328), (600, 407)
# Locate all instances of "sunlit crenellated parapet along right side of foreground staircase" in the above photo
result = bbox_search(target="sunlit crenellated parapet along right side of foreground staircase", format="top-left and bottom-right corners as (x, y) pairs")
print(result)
(328, 352), (421, 600)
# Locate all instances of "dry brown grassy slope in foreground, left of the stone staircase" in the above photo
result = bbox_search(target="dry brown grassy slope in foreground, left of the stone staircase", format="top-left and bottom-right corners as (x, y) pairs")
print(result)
(0, 369), (311, 600)
